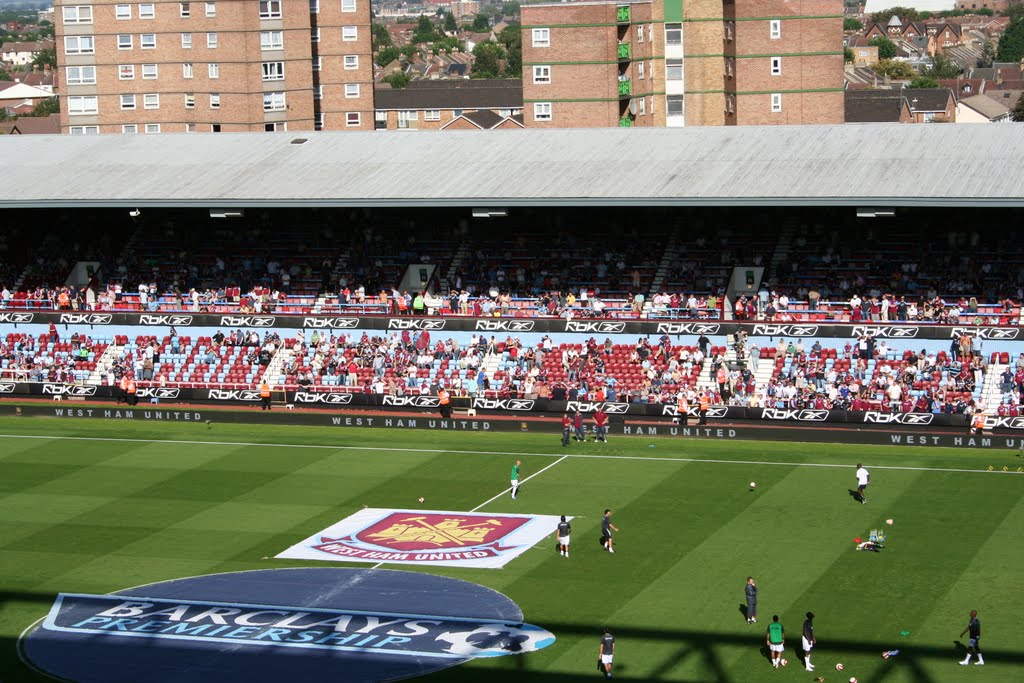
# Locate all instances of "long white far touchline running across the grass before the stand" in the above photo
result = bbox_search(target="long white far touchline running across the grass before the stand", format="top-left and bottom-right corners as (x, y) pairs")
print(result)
(0, 434), (1024, 481)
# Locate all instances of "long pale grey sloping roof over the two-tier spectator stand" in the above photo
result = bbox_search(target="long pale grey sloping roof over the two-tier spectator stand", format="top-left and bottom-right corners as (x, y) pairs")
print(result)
(0, 124), (1024, 208)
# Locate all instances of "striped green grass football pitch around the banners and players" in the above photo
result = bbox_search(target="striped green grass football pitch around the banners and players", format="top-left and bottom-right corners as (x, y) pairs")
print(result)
(0, 418), (1024, 683)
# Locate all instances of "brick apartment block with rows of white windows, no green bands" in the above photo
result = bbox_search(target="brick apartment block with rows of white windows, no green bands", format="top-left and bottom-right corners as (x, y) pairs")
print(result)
(55, 0), (374, 134)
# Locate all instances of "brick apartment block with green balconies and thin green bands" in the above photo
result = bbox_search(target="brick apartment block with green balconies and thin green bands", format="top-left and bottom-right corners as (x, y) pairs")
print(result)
(522, 0), (844, 128)
